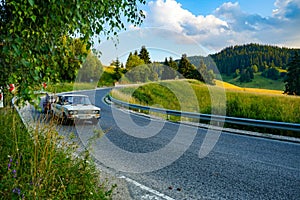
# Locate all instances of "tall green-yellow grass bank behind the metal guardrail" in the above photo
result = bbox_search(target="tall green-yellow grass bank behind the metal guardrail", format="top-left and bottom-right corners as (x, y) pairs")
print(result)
(112, 80), (300, 137)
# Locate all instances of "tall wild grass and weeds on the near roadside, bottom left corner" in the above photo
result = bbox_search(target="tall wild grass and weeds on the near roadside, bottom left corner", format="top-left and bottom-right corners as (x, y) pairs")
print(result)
(0, 109), (115, 199)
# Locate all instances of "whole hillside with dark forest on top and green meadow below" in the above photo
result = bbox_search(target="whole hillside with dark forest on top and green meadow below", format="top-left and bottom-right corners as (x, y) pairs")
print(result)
(183, 44), (300, 90)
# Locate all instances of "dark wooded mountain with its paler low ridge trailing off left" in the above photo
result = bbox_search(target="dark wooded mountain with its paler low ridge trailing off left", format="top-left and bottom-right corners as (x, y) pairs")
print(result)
(184, 44), (300, 75)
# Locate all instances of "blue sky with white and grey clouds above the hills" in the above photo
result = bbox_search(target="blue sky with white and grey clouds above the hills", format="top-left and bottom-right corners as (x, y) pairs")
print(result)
(96, 0), (300, 65)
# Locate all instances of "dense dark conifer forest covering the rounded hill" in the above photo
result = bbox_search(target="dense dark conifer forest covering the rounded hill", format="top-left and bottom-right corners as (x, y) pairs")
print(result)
(203, 43), (300, 82)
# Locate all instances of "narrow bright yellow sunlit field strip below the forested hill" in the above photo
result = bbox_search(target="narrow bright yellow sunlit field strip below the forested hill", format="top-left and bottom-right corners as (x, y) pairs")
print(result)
(216, 80), (285, 95)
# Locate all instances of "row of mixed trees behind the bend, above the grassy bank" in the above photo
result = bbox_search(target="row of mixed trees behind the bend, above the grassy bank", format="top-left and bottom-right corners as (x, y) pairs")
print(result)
(111, 46), (215, 85)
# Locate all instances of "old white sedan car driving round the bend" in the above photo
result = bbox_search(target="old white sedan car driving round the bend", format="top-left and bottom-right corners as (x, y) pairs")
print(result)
(51, 94), (101, 124)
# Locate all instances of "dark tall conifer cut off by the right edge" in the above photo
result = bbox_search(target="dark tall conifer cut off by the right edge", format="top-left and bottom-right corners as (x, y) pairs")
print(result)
(284, 52), (300, 95)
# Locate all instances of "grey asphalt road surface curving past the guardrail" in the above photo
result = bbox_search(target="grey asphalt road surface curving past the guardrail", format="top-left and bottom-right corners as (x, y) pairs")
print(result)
(58, 89), (300, 199)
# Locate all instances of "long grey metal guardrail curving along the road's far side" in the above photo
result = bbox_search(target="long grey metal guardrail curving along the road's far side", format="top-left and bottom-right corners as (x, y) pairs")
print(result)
(108, 95), (300, 132)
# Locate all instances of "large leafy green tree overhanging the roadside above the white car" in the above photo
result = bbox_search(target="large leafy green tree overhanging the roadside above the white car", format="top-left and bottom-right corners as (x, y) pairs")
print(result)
(0, 0), (145, 103)
